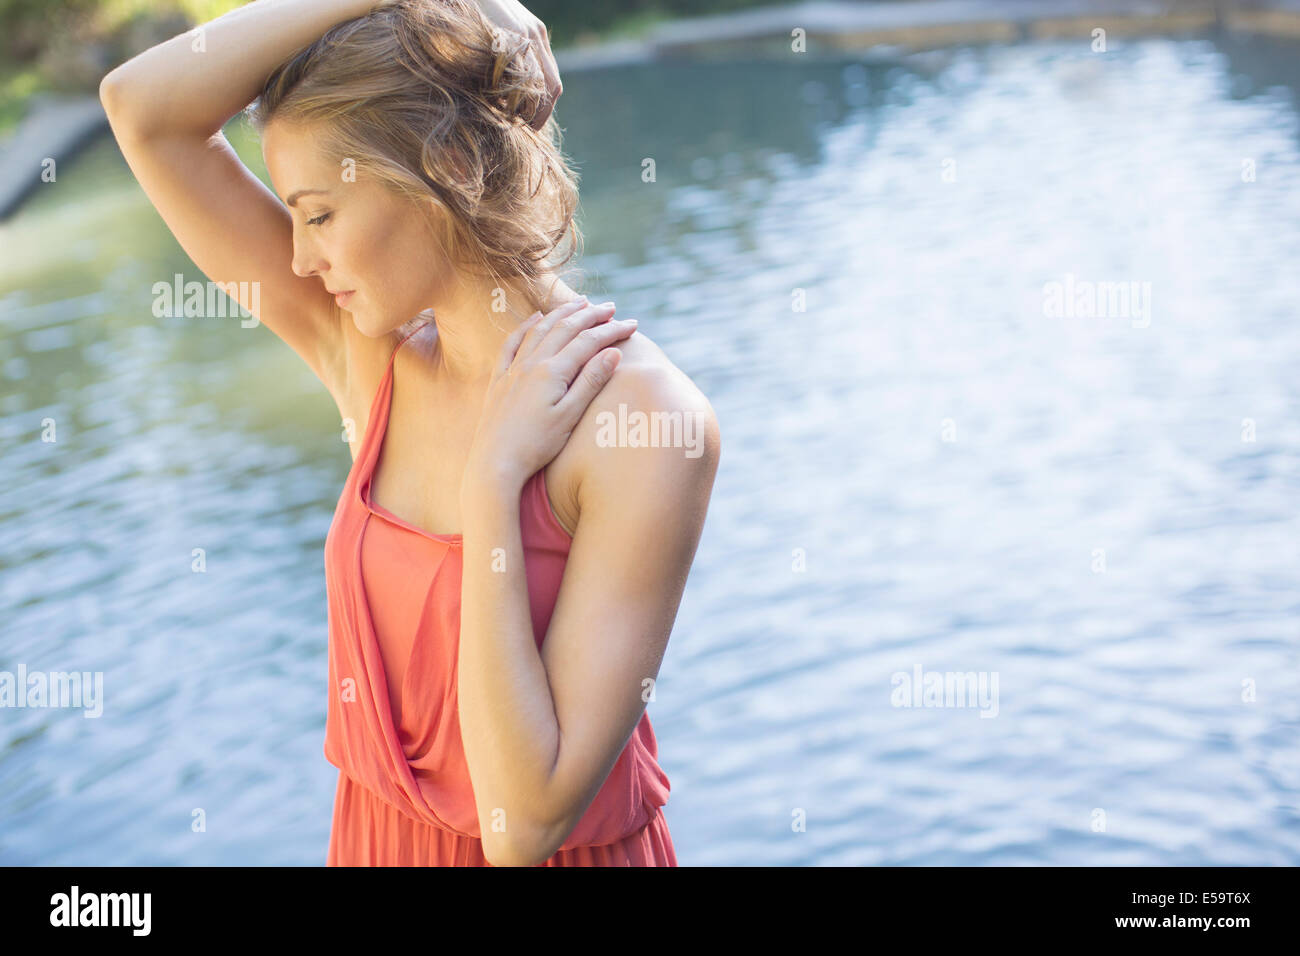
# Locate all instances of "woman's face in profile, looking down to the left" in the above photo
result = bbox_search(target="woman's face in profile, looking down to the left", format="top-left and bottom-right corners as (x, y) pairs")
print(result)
(263, 121), (455, 338)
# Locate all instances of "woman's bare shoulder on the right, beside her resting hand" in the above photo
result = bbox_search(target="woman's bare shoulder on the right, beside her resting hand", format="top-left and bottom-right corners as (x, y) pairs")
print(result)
(553, 332), (722, 528)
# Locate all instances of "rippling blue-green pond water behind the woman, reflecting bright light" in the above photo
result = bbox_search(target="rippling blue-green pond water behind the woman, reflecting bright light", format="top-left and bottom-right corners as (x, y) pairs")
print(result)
(0, 31), (1300, 865)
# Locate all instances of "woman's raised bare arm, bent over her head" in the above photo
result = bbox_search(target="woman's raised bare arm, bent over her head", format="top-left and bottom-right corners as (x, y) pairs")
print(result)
(100, 0), (387, 399)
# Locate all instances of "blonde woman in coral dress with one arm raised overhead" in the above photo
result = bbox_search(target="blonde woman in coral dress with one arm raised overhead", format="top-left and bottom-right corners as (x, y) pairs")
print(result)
(100, 0), (719, 866)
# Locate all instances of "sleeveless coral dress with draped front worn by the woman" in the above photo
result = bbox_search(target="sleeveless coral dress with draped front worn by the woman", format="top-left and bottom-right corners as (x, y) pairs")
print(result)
(325, 323), (677, 866)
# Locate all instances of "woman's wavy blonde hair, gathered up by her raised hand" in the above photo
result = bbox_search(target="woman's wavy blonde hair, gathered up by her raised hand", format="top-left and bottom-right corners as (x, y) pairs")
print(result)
(247, 0), (582, 300)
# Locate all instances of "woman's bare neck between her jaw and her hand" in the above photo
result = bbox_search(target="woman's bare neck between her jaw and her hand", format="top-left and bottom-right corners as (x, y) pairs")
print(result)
(433, 273), (577, 390)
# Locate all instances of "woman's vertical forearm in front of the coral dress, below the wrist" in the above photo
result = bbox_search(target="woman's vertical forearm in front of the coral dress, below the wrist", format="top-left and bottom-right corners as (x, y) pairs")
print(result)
(456, 481), (559, 860)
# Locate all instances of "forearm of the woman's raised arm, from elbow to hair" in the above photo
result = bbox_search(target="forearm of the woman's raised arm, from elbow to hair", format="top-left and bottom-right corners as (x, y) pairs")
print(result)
(100, 0), (380, 138)
